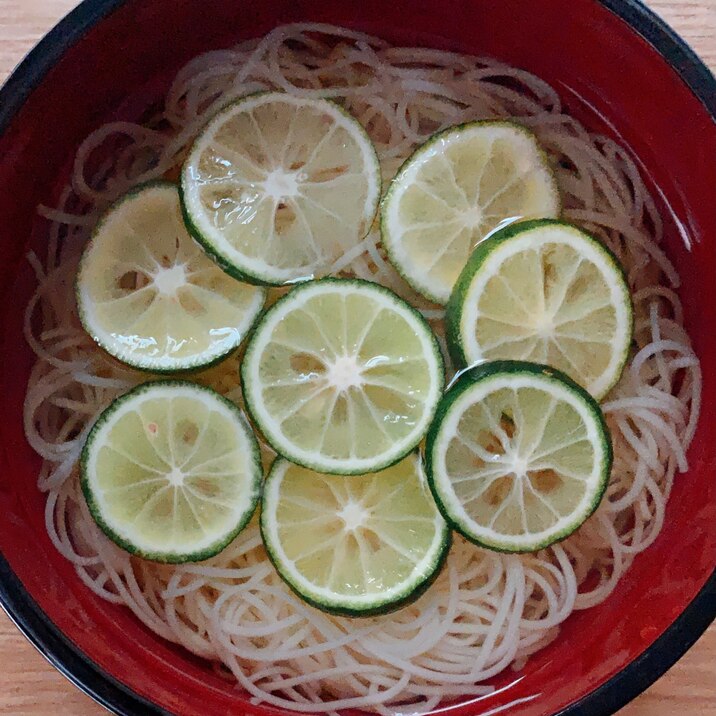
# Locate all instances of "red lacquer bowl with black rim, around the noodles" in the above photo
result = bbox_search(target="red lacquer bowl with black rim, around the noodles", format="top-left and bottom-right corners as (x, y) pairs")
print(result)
(0, 0), (716, 716)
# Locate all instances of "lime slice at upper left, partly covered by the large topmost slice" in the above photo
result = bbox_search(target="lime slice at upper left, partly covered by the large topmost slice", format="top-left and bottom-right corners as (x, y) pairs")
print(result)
(77, 182), (265, 372)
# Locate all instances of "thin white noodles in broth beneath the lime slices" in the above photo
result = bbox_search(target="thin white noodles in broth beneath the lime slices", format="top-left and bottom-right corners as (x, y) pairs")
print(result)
(25, 24), (701, 714)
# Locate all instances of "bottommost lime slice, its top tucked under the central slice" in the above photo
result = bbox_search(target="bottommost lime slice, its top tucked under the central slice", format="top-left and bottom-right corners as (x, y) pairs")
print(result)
(261, 454), (450, 616)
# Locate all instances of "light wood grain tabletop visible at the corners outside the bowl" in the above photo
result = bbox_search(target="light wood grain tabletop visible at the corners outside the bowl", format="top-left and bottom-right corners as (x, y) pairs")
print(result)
(0, 0), (716, 716)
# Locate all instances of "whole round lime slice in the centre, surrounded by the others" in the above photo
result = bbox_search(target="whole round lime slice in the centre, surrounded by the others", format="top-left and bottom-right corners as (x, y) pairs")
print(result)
(241, 279), (444, 475)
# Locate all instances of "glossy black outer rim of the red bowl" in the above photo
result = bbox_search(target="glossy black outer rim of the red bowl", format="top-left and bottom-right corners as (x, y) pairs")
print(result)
(0, 0), (716, 716)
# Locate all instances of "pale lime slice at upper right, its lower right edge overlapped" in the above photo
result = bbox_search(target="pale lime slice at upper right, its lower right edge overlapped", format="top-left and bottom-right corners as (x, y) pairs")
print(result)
(381, 122), (560, 304)
